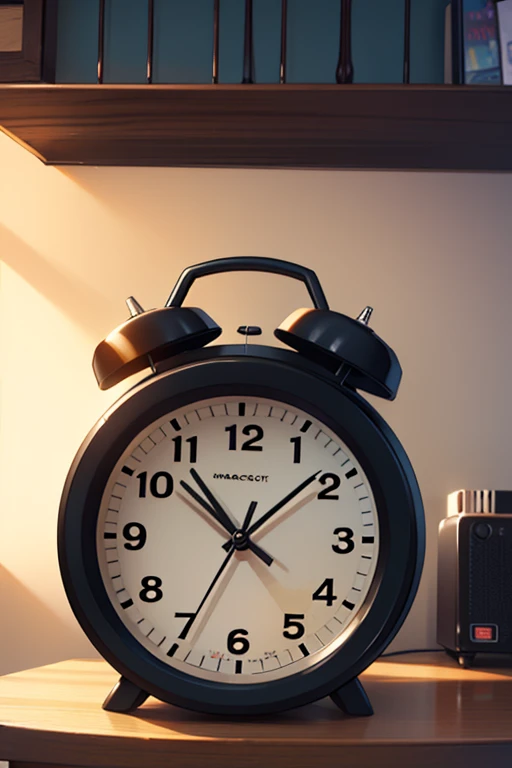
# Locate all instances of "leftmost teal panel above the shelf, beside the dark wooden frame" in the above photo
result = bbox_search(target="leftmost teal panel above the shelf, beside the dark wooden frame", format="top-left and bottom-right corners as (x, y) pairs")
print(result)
(56, 0), (99, 83)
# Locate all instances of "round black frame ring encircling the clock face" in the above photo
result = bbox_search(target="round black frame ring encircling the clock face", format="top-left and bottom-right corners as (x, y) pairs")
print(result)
(58, 346), (425, 715)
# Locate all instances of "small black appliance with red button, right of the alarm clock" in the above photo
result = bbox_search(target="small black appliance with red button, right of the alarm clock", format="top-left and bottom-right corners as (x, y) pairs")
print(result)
(437, 490), (512, 667)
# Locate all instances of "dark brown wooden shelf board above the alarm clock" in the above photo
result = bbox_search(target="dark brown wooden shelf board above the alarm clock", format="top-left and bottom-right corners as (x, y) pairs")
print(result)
(0, 85), (512, 171)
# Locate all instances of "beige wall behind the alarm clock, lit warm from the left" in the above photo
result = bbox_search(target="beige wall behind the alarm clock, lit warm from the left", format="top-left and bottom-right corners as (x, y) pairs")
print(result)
(0, 134), (512, 672)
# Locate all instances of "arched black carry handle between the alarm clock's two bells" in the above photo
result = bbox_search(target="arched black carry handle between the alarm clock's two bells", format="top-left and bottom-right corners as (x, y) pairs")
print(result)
(165, 256), (329, 309)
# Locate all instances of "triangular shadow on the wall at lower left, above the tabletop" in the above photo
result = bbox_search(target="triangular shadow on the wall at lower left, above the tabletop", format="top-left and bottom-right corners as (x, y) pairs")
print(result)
(0, 565), (96, 675)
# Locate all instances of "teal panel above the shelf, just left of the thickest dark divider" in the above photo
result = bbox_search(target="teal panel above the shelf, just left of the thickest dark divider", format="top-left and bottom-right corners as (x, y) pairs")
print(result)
(288, 0), (341, 83)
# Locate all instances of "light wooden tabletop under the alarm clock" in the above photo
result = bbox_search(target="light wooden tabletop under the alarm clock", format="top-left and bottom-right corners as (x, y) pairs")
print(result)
(0, 653), (512, 768)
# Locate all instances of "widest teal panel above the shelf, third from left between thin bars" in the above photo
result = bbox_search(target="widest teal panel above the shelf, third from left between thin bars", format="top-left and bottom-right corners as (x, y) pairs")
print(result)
(153, 0), (214, 83)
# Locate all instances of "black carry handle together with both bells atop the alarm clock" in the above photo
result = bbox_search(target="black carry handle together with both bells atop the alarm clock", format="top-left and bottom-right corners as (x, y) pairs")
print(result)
(93, 256), (402, 400)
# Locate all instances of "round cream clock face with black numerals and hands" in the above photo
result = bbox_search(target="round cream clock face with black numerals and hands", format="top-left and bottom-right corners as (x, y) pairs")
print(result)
(97, 396), (379, 684)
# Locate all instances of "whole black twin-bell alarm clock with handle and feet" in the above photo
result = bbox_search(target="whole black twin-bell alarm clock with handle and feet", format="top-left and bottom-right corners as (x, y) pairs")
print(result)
(58, 257), (425, 715)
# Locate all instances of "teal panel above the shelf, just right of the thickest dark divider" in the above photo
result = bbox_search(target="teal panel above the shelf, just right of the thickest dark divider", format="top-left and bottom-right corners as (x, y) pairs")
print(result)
(352, 0), (404, 83)
